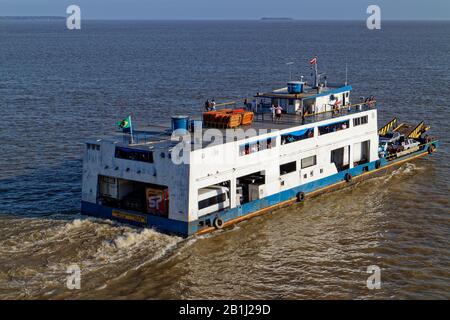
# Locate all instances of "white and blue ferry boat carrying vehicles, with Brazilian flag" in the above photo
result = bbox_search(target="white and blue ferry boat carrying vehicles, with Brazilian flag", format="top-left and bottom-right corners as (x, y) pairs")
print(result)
(81, 58), (439, 236)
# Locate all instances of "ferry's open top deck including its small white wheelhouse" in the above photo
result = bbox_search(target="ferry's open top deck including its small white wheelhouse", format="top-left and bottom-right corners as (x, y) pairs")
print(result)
(89, 62), (375, 150)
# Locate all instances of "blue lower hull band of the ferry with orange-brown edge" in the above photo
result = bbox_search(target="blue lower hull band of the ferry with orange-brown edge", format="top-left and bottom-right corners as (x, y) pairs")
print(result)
(81, 141), (438, 236)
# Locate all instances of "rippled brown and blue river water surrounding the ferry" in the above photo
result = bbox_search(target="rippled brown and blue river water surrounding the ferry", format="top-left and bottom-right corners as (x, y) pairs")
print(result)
(0, 20), (450, 299)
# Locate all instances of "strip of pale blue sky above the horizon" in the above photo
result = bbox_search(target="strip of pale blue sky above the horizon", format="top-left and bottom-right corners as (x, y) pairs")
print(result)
(0, 0), (450, 20)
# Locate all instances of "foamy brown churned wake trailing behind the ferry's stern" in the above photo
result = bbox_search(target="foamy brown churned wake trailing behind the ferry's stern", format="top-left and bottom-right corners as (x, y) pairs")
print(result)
(0, 215), (183, 299)
